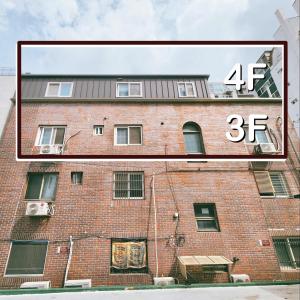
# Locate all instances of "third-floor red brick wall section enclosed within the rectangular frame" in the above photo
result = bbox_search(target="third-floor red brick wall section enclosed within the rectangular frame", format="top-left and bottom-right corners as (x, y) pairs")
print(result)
(21, 102), (281, 155)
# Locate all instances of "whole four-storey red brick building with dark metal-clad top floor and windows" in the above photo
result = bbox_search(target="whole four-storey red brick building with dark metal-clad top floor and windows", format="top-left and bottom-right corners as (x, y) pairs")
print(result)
(0, 75), (300, 288)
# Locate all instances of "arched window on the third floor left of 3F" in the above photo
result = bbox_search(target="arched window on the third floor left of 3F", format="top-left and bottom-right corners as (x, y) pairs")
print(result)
(183, 122), (205, 154)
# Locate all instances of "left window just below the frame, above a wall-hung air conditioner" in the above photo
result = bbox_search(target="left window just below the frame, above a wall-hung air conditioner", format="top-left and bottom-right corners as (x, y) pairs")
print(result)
(25, 173), (58, 201)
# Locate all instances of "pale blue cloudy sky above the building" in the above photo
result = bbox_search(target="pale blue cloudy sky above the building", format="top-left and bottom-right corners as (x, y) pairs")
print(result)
(0, 0), (295, 81)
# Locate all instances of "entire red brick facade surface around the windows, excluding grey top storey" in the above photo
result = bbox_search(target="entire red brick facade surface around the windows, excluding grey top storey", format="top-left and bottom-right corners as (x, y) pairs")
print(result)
(0, 75), (300, 288)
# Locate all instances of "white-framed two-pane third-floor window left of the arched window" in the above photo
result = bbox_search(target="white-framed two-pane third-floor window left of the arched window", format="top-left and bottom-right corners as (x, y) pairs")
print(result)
(115, 125), (143, 146)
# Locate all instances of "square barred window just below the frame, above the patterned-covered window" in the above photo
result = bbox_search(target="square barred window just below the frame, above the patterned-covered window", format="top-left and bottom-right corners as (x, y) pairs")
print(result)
(114, 172), (144, 199)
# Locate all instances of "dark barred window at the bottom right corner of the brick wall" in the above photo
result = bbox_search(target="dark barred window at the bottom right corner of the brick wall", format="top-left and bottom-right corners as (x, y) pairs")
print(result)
(273, 238), (300, 269)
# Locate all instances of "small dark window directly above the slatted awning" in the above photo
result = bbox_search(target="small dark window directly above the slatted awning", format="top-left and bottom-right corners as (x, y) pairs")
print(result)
(194, 203), (220, 231)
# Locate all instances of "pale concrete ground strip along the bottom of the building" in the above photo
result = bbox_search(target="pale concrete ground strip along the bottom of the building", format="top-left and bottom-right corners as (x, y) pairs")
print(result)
(0, 284), (300, 300)
